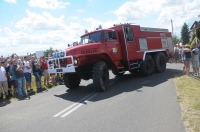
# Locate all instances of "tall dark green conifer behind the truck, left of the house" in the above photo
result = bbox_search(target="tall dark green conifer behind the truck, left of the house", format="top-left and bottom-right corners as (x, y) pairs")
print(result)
(181, 23), (190, 45)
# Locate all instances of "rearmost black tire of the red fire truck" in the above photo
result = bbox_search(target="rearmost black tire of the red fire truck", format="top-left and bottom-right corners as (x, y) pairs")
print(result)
(154, 52), (166, 73)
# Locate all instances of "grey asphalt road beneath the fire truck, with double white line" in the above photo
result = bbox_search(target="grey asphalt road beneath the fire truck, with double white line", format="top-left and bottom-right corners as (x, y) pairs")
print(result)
(0, 64), (185, 132)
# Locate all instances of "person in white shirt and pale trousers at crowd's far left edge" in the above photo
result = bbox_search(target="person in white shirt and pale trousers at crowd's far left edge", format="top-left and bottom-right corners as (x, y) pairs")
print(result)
(0, 61), (8, 99)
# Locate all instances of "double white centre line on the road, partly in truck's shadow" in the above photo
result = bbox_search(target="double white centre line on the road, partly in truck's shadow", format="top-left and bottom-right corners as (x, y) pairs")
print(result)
(53, 78), (120, 118)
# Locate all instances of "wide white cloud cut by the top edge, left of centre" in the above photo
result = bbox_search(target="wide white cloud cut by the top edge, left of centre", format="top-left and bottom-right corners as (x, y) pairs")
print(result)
(29, 0), (70, 9)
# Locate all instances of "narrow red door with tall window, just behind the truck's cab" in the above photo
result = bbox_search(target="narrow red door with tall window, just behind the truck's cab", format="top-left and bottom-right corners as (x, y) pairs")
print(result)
(123, 26), (137, 62)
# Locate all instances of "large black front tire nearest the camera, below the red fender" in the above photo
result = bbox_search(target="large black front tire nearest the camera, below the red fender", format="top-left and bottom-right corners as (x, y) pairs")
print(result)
(92, 61), (109, 92)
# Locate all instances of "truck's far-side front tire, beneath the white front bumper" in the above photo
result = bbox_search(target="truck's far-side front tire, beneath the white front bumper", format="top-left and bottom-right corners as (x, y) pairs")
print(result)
(64, 73), (81, 89)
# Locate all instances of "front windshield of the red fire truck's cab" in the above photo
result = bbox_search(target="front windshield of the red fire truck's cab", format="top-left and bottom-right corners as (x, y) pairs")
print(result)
(80, 32), (103, 44)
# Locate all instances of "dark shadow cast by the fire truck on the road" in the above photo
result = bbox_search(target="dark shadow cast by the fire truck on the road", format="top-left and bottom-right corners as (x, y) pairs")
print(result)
(54, 69), (183, 102)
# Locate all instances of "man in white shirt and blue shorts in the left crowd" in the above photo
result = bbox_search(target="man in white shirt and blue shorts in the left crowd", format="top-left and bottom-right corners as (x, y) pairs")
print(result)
(24, 56), (33, 92)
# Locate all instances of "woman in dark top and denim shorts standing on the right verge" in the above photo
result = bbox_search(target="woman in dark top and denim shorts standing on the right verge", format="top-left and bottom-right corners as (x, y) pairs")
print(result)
(182, 45), (192, 76)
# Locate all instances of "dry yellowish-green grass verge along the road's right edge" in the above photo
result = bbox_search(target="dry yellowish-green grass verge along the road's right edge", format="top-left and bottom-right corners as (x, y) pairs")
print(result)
(174, 76), (200, 132)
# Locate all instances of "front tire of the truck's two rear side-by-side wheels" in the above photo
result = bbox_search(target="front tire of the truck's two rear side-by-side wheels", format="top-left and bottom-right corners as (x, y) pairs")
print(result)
(139, 55), (154, 76)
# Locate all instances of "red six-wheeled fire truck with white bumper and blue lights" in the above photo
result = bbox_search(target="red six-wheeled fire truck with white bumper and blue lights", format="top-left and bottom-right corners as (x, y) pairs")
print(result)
(48, 24), (173, 91)
